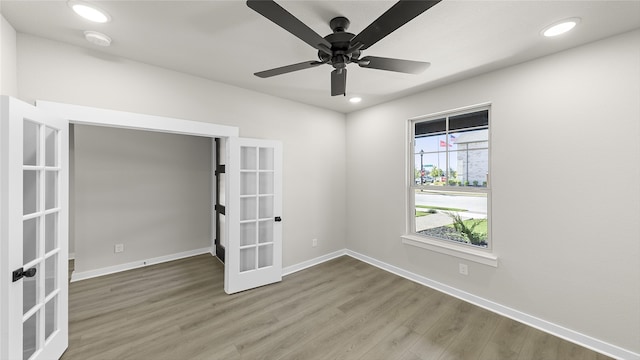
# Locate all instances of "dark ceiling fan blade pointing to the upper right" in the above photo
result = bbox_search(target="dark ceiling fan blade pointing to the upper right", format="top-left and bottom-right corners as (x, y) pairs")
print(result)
(351, 0), (441, 50)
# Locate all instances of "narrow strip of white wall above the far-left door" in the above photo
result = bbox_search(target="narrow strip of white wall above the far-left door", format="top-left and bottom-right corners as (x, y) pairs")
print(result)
(0, 14), (18, 96)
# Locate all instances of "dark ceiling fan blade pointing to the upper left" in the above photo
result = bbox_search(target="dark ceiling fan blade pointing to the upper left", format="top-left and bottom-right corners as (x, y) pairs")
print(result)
(247, 0), (331, 55)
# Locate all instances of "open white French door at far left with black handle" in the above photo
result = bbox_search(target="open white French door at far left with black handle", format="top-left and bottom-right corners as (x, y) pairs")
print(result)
(0, 96), (69, 360)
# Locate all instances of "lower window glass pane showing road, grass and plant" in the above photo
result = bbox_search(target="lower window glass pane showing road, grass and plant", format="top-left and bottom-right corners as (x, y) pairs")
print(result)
(414, 190), (488, 247)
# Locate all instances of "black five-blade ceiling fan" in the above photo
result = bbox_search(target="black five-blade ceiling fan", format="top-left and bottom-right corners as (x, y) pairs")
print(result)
(247, 0), (441, 96)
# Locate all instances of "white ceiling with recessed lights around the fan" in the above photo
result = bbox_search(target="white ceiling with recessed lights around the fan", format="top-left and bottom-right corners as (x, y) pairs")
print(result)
(0, 0), (640, 113)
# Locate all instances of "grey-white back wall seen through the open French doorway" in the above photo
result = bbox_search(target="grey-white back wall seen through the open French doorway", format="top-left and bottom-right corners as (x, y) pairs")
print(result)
(73, 125), (212, 273)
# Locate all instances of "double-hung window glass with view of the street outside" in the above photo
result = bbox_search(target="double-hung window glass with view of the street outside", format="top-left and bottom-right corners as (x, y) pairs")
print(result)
(408, 106), (491, 248)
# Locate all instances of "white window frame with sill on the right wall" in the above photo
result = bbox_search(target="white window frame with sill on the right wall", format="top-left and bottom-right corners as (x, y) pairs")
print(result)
(401, 103), (498, 267)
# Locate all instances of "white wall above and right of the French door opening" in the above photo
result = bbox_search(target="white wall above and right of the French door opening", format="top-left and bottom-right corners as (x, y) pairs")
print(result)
(17, 34), (346, 266)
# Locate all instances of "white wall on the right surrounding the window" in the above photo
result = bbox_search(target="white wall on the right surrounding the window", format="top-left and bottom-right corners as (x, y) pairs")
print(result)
(347, 31), (640, 353)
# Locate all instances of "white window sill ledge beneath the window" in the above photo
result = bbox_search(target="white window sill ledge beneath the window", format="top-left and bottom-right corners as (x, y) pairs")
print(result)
(401, 234), (498, 267)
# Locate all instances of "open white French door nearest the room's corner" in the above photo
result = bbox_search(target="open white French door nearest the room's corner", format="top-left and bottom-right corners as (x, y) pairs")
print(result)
(224, 137), (282, 294)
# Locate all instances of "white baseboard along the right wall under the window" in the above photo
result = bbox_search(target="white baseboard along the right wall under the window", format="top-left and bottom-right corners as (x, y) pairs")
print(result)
(346, 250), (640, 360)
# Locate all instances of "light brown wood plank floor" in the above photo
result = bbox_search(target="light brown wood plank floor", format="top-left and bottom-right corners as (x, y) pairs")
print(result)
(62, 255), (608, 360)
